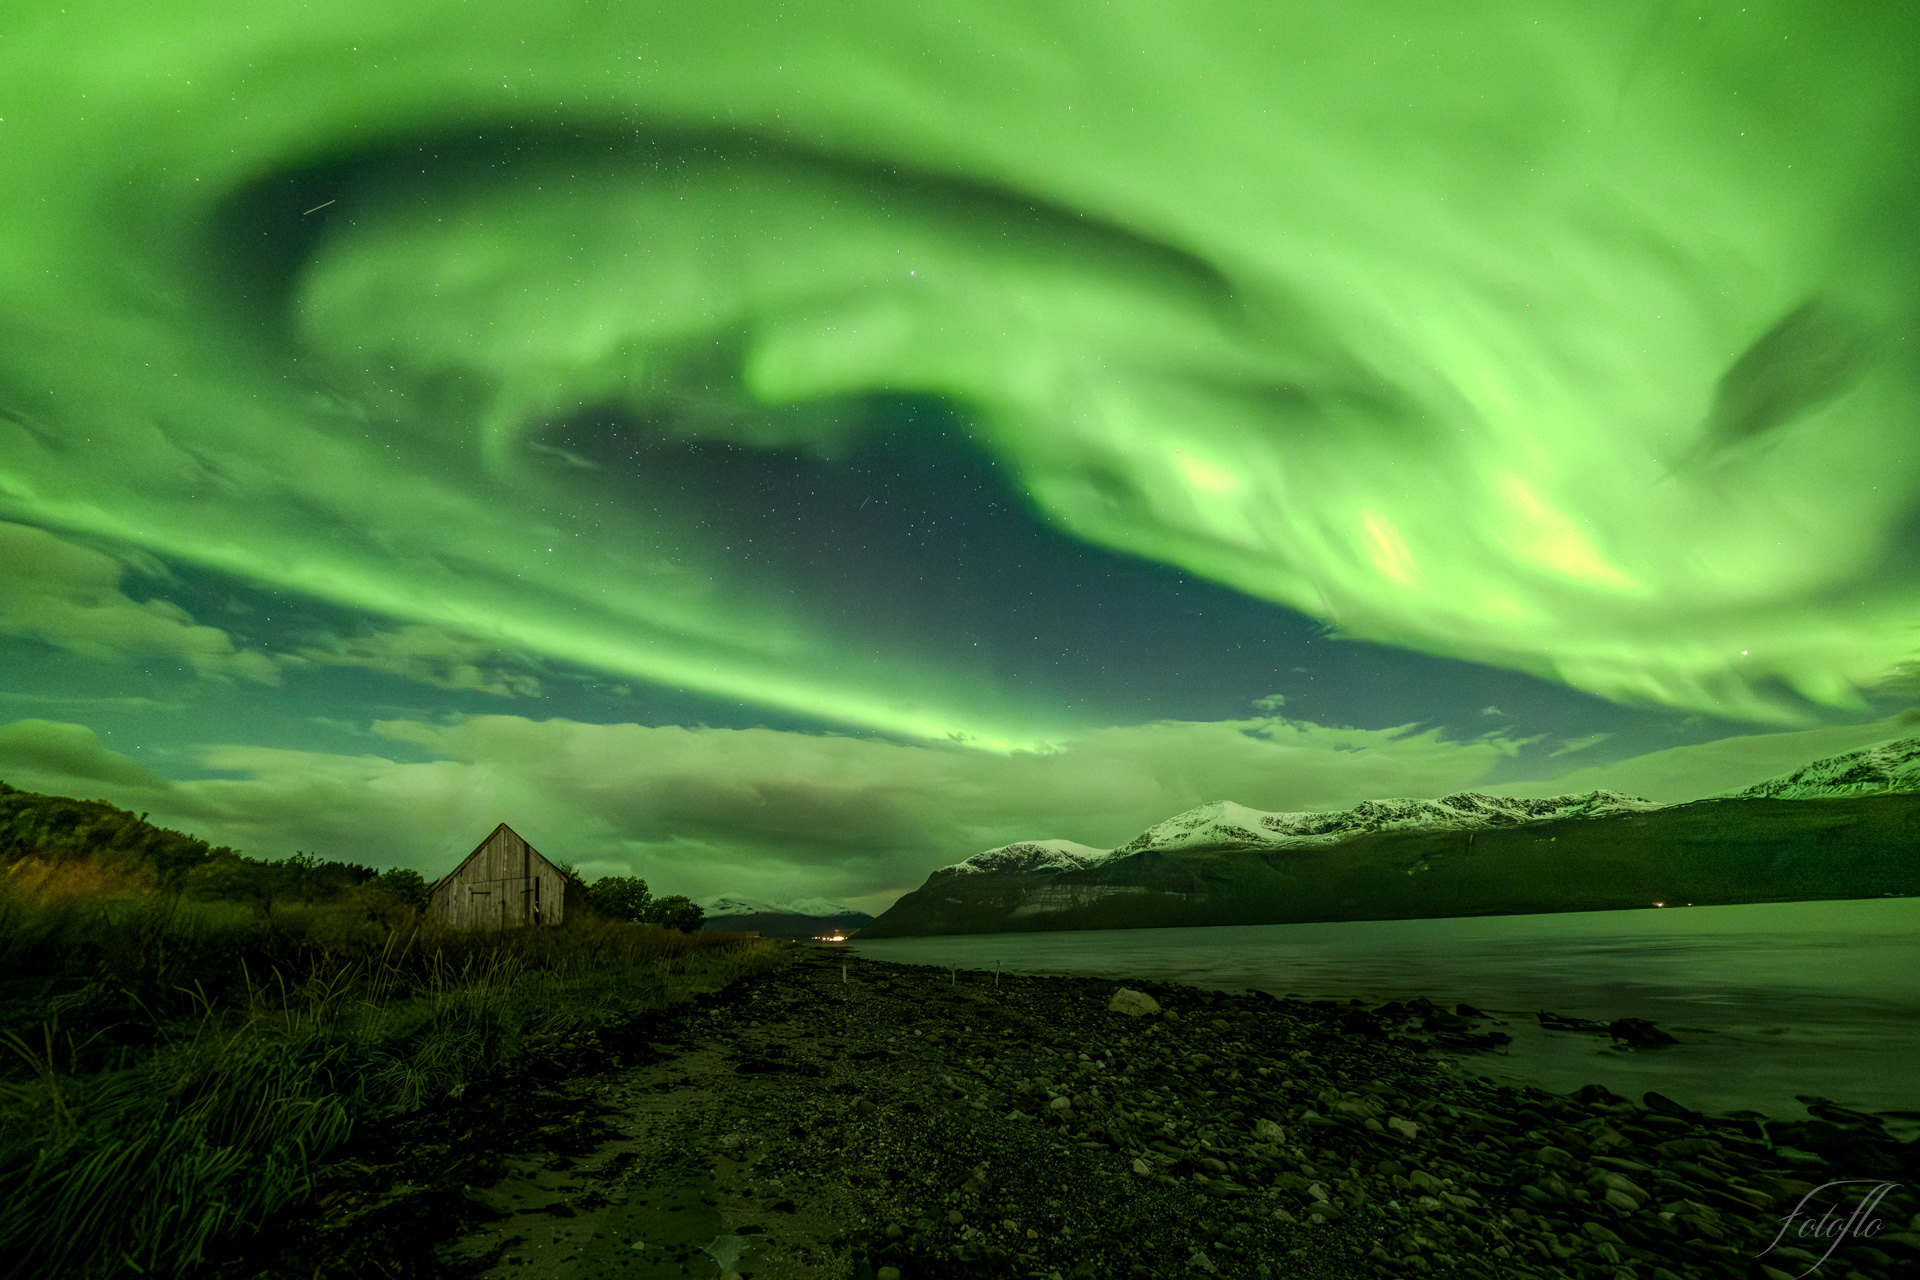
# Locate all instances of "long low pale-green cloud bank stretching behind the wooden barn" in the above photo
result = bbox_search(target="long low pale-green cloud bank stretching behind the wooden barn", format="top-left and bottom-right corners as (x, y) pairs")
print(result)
(8, 716), (1509, 902)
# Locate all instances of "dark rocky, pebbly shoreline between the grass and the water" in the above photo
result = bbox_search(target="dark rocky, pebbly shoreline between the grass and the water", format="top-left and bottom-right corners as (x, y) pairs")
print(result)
(238, 950), (1920, 1280)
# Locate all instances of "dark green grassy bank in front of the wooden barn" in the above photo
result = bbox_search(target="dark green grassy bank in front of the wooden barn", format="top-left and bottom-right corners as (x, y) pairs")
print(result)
(0, 860), (783, 1278)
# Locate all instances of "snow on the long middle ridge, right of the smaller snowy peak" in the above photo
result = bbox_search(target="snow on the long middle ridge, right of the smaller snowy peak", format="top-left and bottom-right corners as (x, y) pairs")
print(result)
(1116, 791), (1661, 854)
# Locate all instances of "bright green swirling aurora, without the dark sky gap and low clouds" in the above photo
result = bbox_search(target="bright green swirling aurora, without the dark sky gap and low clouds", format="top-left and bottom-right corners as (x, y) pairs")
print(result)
(0, 0), (1920, 747)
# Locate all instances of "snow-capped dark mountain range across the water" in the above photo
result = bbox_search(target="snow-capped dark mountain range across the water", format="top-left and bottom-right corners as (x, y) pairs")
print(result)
(862, 739), (1920, 938)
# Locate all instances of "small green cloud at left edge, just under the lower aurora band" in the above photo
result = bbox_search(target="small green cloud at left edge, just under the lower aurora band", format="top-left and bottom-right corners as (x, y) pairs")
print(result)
(0, 522), (280, 683)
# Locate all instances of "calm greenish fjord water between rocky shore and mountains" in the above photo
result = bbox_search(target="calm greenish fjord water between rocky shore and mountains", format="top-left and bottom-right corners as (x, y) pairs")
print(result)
(854, 898), (1920, 1132)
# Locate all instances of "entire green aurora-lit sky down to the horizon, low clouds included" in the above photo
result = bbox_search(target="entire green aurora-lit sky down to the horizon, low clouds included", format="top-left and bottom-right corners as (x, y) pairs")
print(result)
(0, 0), (1920, 894)
